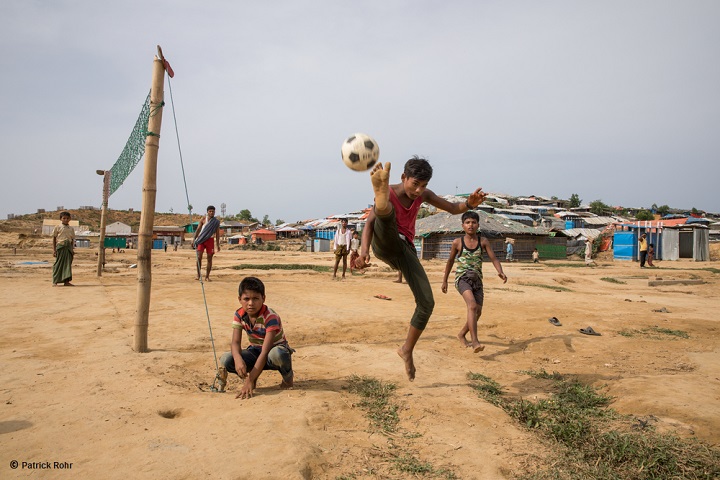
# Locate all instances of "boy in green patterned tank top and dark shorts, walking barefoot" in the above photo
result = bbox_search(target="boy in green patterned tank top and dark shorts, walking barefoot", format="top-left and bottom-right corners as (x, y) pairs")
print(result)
(442, 212), (507, 353)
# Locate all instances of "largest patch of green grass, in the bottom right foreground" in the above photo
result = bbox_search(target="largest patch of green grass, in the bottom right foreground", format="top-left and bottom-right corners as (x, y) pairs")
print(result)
(468, 370), (720, 480)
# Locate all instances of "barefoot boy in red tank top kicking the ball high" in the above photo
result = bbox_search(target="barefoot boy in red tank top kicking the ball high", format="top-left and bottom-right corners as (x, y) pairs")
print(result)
(358, 156), (485, 381)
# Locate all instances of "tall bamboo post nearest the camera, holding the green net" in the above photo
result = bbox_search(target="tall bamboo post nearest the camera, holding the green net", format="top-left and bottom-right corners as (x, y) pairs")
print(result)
(134, 51), (165, 353)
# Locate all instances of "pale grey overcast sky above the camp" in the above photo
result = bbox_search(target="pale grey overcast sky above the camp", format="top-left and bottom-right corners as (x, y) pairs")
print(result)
(0, 0), (720, 223)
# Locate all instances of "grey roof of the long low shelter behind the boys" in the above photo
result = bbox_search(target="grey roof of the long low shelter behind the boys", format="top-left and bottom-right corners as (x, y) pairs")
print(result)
(415, 210), (550, 237)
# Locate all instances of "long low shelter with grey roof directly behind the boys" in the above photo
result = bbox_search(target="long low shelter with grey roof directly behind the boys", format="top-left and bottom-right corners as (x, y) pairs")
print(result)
(415, 210), (556, 260)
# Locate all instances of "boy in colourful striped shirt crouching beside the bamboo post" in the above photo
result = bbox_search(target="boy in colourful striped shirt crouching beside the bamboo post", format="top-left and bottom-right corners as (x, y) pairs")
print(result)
(218, 277), (295, 398)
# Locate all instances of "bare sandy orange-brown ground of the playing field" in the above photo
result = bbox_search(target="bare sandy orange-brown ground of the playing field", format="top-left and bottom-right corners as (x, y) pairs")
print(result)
(0, 240), (720, 480)
